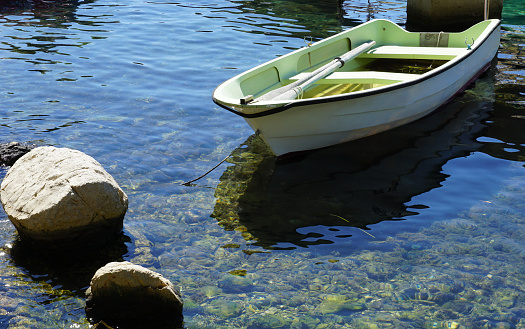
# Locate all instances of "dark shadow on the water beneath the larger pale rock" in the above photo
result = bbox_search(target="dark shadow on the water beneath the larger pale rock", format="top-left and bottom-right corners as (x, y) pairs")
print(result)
(10, 233), (131, 298)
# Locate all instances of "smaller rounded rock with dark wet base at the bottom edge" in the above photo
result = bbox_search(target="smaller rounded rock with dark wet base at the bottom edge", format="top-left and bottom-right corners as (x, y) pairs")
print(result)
(86, 262), (183, 328)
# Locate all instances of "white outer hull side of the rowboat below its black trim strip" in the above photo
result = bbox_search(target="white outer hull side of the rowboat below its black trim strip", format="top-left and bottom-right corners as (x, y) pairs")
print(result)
(245, 59), (491, 157)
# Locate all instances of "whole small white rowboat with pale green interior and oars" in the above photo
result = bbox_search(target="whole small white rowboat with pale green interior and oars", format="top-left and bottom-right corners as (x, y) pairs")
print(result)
(213, 19), (500, 156)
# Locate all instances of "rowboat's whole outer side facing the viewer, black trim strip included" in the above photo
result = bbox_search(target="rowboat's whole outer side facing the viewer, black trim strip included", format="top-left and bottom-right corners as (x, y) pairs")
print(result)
(212, 18), (500, 156)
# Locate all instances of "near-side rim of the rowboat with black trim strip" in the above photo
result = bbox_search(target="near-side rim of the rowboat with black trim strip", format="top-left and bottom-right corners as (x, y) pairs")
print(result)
(213, 19), (501, 119)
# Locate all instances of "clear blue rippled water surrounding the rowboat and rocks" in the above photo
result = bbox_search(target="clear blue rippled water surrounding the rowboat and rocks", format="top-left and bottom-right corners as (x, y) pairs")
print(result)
(0, 0), (525, 328)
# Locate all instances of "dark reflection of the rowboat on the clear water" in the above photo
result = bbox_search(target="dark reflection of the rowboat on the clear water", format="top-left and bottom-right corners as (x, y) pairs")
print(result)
(212, 76), (494, 249)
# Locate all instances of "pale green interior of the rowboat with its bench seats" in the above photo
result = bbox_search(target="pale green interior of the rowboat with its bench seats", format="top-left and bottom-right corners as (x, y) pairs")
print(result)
(233, 21), (491, 103)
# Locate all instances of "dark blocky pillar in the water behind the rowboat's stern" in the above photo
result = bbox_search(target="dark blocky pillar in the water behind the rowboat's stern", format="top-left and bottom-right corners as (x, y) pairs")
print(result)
(407, 0), (503, 31)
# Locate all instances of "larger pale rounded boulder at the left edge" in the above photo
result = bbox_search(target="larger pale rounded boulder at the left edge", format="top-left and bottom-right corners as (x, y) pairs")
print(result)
(0, 146), (128, 247)
